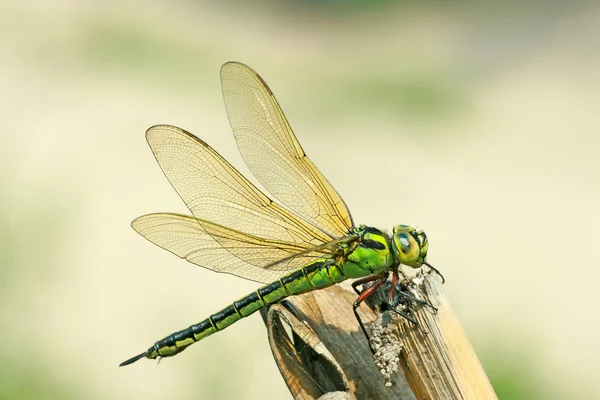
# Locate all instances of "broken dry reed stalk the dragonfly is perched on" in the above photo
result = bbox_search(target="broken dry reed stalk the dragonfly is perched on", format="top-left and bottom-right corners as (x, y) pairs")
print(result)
(262, 273), (497, 400)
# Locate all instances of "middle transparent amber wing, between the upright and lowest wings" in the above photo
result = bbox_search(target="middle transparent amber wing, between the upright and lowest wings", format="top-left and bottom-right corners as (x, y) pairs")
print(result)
(146, 125), (333, 246)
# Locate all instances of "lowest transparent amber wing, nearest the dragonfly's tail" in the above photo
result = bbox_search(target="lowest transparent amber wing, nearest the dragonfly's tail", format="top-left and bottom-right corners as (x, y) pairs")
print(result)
(131, 214), (346, 283)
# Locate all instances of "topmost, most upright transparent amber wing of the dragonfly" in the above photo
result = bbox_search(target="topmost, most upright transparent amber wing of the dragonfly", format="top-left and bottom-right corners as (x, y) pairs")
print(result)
(221, 62), (354, 237)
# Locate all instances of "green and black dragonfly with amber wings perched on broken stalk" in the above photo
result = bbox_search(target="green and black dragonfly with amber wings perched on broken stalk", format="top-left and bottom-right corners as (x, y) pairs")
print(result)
(120, 62), (443, 366)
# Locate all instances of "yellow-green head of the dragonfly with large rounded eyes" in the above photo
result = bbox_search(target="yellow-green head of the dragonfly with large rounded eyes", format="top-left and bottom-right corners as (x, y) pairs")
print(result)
(391, 225), (429, 268)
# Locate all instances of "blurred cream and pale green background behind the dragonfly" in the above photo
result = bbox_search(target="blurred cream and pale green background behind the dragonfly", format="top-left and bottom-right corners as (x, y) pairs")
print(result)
(0, 0), (600, 399)
